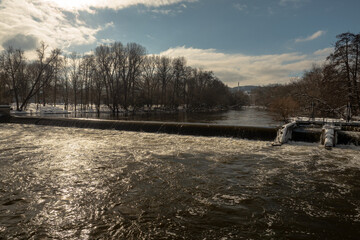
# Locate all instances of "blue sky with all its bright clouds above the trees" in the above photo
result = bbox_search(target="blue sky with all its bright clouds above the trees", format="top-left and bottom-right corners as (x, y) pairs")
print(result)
(0, 0), (360, 87)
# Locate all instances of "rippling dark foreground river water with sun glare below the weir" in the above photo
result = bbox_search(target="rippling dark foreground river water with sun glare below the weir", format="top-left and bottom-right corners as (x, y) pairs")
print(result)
(0, 124), (360, 239)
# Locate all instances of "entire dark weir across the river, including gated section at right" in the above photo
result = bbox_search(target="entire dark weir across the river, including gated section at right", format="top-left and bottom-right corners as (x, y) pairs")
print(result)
(4, 116), (360, 145)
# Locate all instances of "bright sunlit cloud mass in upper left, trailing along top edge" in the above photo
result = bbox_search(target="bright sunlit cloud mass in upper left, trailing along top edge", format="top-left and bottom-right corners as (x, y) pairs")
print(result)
(0, 0), (197, 54)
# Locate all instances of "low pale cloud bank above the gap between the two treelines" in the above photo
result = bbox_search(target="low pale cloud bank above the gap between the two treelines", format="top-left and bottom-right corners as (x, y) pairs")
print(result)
(160, 46), (326, 86)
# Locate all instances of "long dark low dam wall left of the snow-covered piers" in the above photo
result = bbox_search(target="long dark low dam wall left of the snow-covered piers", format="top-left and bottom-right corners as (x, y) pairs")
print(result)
(10, 117), (277, 141)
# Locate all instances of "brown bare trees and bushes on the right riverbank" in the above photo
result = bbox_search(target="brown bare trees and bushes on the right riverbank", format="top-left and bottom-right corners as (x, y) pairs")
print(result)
(252, 32), (360, 120)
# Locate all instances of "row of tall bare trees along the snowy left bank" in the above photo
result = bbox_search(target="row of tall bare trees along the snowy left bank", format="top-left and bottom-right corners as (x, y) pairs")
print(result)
(0, 42), (248, 113)
